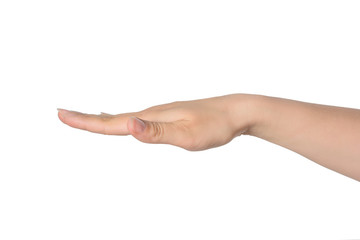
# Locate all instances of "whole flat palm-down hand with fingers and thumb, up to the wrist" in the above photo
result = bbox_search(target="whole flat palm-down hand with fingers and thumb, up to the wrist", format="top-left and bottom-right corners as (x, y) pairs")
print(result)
(58, 94), (253, 151)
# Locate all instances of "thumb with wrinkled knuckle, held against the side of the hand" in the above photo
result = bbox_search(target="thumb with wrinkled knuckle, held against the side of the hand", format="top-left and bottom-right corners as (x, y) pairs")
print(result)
(127, 117), (184, 145)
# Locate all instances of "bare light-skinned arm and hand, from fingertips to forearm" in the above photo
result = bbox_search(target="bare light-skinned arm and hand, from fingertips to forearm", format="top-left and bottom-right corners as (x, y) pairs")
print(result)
(58, 94), (360, 181)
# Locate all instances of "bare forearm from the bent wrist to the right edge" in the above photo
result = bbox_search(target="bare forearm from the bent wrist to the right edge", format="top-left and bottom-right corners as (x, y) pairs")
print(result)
(233, 95), (360, 181)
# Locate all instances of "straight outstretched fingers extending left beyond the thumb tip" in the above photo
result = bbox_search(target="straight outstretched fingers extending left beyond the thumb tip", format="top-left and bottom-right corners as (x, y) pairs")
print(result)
(58, 109), (133, 135)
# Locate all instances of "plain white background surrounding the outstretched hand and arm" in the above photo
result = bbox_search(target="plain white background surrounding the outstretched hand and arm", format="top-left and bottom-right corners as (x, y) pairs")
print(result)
(0, 0), (360, 240)
